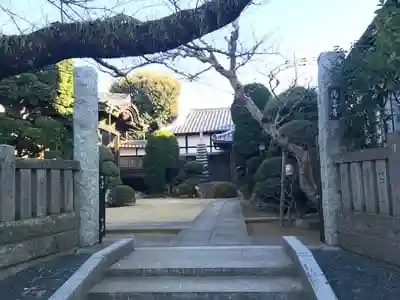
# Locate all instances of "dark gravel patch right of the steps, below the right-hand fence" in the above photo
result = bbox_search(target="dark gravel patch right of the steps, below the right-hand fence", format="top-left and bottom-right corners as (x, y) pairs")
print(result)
(312, 249), (400, 300)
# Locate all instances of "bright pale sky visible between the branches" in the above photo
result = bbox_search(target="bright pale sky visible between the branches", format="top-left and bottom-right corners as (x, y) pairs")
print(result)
(0, 0), (378, 115)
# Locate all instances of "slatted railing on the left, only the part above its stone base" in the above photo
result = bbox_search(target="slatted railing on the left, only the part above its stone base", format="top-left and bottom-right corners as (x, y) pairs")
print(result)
(0, 159), (79, 221)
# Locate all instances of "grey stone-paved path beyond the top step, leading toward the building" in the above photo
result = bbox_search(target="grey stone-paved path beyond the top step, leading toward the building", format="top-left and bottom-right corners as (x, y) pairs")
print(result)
(170, 199), (251, 246)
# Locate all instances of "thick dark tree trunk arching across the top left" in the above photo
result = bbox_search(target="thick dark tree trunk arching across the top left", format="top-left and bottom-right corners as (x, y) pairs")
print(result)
(0, 0), (251, 79)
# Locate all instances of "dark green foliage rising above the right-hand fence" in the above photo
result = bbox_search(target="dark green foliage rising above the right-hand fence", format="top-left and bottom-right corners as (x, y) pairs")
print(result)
(335, 0), (400, 150)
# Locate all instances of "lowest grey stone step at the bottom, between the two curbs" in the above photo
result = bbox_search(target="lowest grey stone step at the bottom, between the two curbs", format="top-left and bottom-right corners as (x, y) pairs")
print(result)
(88, 276), (305, 300)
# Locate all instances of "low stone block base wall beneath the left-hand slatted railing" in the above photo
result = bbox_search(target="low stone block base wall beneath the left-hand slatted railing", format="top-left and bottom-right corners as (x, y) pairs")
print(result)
(0, 212), (79, 268)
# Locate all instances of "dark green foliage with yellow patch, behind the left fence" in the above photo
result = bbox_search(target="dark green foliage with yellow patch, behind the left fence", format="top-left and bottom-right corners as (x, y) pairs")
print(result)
(0, 60), (74, 157)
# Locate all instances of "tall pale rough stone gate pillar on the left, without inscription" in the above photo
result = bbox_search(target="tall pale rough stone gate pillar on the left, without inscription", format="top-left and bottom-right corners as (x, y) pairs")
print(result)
(73, 66), (99, 246)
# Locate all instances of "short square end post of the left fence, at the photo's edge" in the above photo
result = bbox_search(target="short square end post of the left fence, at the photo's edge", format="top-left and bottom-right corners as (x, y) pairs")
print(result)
(0, 145), (15, 222)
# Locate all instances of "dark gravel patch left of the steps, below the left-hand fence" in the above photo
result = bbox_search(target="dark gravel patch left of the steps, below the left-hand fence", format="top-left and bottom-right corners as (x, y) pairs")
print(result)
(0, 254), (90, 300)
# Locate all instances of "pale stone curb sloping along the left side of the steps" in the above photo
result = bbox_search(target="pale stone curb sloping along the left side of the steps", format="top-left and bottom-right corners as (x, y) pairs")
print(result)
(49, 239), (134, 300)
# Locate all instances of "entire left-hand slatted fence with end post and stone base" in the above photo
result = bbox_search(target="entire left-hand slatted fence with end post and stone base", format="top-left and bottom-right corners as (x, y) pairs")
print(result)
(0, 145), (80, 268)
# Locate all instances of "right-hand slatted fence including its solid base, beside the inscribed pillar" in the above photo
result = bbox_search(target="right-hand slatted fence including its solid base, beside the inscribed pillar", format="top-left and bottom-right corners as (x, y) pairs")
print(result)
(334, 134), (400, 265)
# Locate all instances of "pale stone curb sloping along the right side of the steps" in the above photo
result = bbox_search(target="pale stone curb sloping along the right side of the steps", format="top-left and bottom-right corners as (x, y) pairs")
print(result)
(282, 236), (338, 300)
